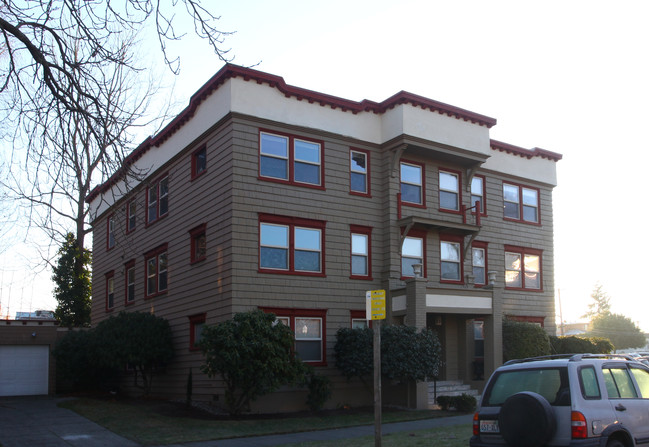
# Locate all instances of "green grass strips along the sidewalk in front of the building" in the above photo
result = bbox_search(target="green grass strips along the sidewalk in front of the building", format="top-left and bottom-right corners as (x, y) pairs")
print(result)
(61, 398), (471, 447)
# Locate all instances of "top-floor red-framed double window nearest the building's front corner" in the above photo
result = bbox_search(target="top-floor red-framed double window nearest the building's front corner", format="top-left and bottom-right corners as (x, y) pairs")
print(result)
(259, 131), (324, 187)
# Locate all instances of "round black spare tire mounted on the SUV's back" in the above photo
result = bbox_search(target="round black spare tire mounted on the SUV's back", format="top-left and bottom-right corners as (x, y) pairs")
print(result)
(498, 391), (556, 447)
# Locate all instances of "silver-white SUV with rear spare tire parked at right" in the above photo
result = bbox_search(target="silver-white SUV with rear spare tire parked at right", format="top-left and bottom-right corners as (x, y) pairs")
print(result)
(470, 354), (649, 447)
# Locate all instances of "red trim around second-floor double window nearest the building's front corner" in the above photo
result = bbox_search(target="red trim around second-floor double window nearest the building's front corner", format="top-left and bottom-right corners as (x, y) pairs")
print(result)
(257, 213), (327, 277)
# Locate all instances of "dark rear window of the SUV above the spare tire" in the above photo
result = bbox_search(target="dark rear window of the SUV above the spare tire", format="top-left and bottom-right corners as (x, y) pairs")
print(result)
(483, 368), (570, 407)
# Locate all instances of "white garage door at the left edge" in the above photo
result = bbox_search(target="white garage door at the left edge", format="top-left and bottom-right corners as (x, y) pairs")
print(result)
(0, 345), (50, 396)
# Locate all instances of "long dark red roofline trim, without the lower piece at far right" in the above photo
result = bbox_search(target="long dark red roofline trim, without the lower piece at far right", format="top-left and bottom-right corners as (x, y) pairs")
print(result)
(86, 64), (496, 202)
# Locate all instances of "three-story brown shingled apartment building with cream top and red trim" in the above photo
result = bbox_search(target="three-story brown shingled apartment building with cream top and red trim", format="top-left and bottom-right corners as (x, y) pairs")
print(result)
(89, 65), (561, 410)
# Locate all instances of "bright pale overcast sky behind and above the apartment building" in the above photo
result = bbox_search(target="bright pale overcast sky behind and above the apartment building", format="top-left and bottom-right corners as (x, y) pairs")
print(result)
(0, 0), (649, 331)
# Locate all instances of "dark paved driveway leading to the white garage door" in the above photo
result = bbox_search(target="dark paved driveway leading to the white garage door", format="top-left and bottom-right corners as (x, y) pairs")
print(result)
(0, 396), (138, 447)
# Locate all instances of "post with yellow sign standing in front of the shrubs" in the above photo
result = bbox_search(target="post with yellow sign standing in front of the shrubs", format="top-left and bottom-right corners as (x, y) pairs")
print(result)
(365, 290), (385, 447)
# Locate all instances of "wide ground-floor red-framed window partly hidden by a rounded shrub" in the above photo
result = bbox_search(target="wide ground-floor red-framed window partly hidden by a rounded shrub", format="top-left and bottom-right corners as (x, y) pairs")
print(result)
(262, 308), (327, 366)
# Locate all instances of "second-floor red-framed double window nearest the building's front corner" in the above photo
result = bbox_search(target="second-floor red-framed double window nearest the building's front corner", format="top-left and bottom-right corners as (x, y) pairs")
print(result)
(259, 214), (325, 276)
